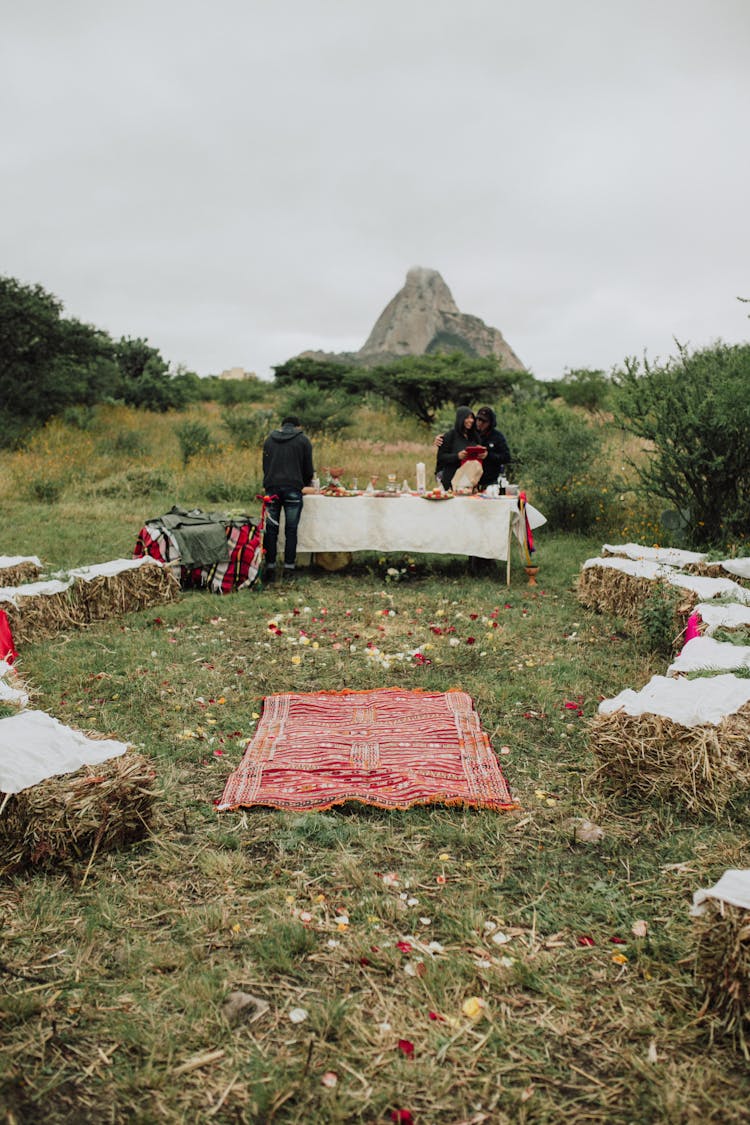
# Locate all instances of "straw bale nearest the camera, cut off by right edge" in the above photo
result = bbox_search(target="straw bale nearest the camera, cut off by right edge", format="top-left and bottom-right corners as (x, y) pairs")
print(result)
(693, 871), (750, 1059)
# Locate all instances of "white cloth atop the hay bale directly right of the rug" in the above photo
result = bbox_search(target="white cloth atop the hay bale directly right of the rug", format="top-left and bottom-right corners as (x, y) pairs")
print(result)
(599, 674), (750, 727)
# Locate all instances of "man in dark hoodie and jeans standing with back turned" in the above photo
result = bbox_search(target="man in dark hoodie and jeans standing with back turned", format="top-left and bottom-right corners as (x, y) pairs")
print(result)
(263, 414), (315, 578)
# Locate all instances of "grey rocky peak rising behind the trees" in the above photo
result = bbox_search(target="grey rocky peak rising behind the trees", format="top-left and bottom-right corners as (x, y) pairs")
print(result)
(302, 266), (525, 371)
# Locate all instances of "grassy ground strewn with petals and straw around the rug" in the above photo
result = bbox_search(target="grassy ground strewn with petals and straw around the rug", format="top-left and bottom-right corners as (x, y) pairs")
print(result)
(0, 417), (750, 1125)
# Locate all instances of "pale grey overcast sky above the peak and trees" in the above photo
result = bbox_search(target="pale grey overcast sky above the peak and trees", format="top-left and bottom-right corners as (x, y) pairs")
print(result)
(0, 0), (750, 378)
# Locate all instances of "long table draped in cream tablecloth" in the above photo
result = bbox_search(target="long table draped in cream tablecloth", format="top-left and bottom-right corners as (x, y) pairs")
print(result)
(297, 493), (546, 584)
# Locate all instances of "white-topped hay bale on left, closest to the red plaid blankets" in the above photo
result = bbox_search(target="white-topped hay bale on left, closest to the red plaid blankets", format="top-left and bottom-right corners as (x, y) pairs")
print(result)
(71, 558), (180, 624)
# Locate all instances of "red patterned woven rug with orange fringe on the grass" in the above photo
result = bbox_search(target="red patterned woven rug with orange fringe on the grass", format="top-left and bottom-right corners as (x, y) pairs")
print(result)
(213, 687), (516, 812)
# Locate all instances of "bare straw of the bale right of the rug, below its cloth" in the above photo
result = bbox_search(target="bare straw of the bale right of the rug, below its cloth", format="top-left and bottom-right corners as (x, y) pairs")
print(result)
(590, 705), (750, 813)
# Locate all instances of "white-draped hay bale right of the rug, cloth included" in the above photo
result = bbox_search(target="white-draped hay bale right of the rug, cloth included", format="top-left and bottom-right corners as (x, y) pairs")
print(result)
(589, 675), (750, 813)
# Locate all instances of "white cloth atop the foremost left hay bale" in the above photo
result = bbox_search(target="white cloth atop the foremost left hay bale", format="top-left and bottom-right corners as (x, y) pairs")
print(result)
(0, 711), (128, 793)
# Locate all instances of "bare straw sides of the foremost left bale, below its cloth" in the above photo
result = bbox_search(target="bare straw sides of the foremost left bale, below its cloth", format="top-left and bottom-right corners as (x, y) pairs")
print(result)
(0, 750), (157, 876)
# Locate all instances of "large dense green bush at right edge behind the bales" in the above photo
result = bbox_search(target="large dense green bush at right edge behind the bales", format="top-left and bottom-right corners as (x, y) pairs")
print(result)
(614, 342), (750, 546)
